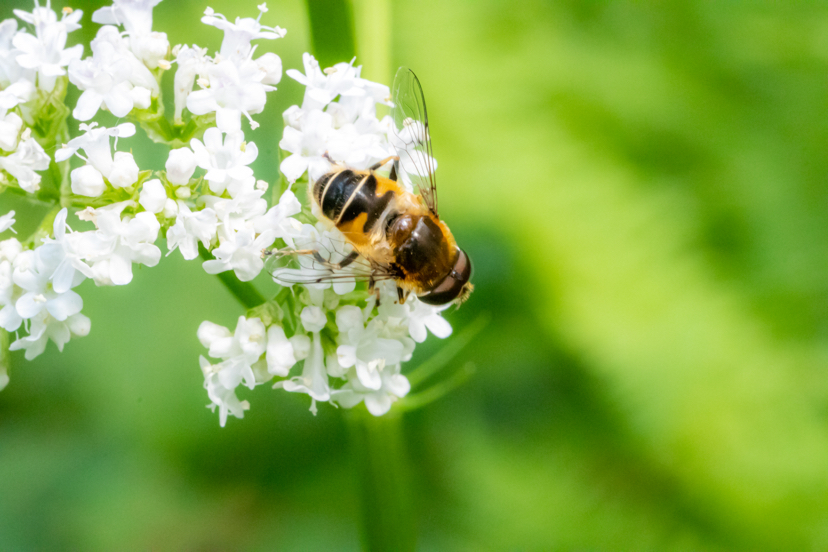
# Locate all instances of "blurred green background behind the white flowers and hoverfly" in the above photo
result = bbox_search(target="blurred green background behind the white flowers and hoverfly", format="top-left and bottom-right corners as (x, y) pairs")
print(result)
(0, 0), (828, 550)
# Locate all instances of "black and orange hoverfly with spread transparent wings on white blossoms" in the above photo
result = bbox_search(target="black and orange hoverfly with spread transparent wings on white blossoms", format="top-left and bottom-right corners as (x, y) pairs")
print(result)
(270, 67), (473, 305)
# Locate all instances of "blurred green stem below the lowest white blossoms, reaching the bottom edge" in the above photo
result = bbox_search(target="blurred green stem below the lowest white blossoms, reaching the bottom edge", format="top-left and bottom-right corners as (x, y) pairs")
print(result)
(349, 408), (417, 552)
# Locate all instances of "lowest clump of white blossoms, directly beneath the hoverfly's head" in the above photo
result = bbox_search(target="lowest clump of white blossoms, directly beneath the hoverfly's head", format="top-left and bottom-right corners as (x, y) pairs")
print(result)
(198, 284), (451, 426)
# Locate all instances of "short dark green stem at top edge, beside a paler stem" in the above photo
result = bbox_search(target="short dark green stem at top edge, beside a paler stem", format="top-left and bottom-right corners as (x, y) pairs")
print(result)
(306, 0), (356, 68)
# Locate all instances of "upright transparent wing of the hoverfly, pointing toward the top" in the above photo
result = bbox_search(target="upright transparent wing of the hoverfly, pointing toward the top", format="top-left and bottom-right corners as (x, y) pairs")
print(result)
(391, 67), (437, 215)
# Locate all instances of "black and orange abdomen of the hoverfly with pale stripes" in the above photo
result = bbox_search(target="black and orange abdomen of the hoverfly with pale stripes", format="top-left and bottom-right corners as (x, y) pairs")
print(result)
(313, 169), (400, 242)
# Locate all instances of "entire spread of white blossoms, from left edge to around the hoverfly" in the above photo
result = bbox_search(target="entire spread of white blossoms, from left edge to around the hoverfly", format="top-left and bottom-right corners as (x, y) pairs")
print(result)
(0, 0), (460, 426)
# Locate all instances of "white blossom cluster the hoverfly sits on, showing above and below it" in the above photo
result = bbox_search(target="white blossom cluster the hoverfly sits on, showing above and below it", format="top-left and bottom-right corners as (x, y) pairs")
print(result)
(198, 59), (452, 426)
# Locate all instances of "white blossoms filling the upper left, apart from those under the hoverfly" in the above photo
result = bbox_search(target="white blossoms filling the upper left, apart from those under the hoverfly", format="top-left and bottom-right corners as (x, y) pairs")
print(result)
(0, 0), (288, 381)
